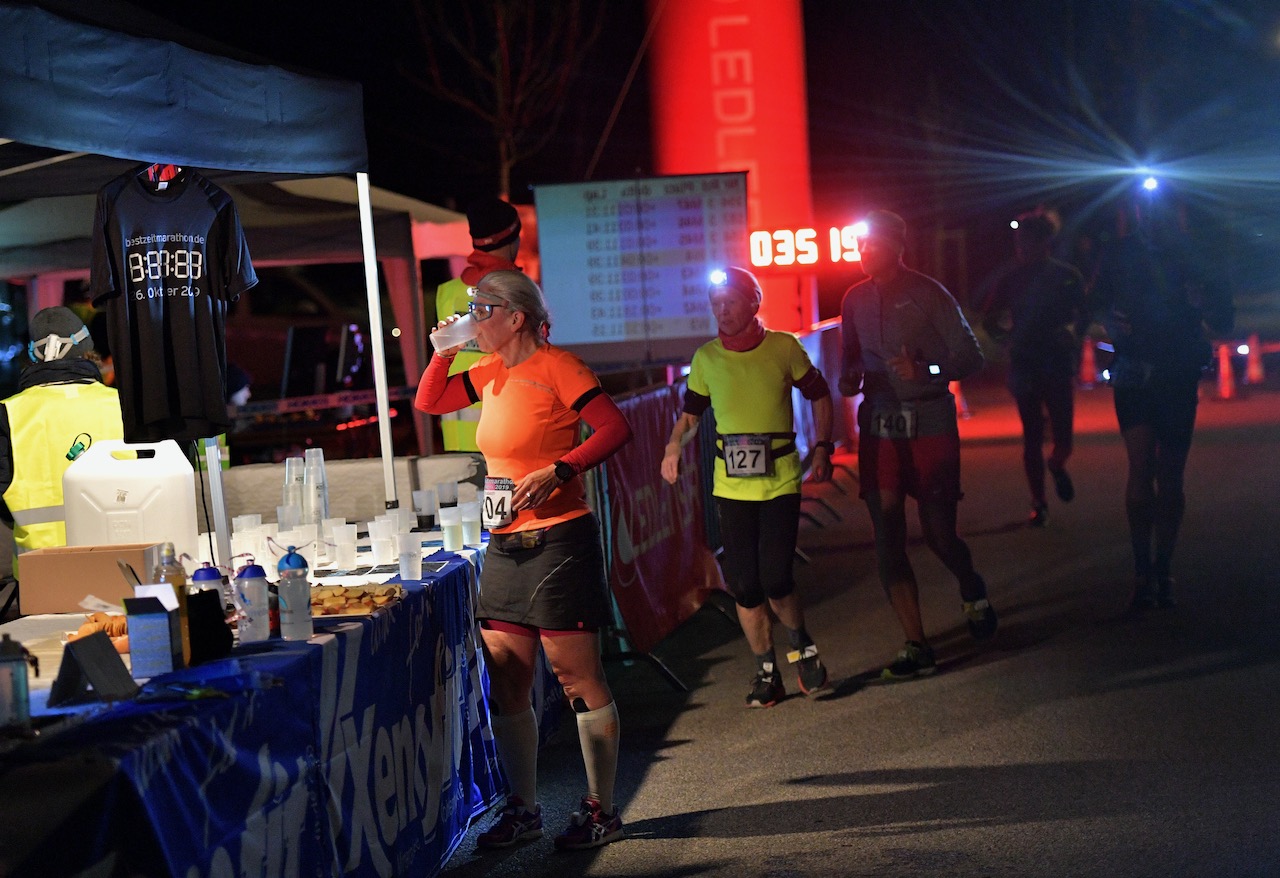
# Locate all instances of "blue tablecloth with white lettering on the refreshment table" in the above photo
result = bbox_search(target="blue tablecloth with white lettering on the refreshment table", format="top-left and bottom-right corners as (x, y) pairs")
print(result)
(0, 554), (504, 878)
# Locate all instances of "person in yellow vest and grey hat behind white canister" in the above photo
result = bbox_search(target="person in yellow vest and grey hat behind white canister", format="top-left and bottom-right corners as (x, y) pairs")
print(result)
(0, 306), (124, 580)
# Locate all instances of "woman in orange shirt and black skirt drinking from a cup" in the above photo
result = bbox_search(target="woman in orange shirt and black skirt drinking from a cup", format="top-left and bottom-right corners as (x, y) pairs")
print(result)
(415, 270), (631, 850)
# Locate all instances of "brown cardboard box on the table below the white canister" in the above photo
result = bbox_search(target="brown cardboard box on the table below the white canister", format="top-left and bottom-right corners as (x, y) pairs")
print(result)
(18, 543), (160, 616)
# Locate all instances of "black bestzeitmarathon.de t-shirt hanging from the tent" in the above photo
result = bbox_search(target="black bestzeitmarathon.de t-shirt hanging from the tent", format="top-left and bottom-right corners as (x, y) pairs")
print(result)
(90, 166), (257, 442)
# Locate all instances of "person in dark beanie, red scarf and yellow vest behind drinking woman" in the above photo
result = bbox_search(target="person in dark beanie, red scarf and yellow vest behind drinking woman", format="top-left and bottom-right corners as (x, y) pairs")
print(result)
(435, 198), (520, 453)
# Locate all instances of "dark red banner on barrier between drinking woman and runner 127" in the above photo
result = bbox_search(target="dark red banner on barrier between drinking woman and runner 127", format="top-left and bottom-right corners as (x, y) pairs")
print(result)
(604, 387), (723, 653)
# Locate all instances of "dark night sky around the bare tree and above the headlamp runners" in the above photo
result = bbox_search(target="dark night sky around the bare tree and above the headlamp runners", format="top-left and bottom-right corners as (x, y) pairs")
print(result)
(124, 0), (1280, 305)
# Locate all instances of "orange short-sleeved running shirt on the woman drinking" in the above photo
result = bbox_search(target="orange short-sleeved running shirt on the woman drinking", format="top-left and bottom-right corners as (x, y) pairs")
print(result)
(467, 344), (600, 534)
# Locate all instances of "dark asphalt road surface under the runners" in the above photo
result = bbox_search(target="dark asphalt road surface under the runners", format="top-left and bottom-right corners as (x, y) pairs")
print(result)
(444, 384), (1280, 878)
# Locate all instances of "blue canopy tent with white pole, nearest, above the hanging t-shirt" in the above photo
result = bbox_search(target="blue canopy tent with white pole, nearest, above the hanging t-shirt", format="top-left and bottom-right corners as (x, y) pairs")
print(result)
(0, 0), (430, 558)
